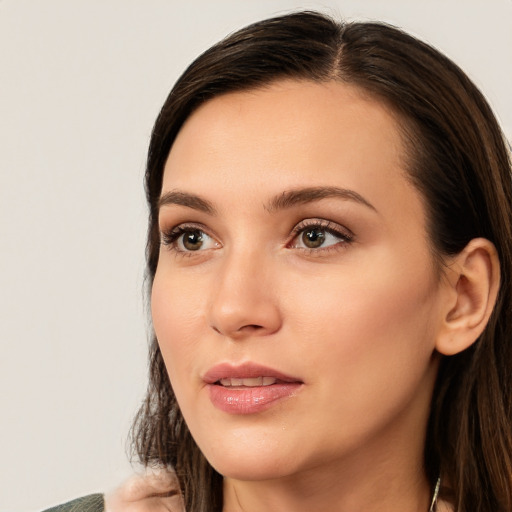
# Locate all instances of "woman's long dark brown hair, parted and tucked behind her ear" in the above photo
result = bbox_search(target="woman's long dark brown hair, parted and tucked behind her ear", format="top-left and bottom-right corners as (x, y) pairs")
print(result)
(133, 12), (512, 512)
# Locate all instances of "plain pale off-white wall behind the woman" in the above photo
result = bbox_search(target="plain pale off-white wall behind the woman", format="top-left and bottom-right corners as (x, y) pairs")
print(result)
(0, 0), (512, 512)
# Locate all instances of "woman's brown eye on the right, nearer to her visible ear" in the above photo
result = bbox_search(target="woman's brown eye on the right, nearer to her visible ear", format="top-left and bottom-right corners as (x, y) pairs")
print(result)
(291, 219), (353, 250)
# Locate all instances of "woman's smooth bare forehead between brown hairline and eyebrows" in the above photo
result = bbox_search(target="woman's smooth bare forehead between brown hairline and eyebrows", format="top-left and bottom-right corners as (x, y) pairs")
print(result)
(163, 80), (418, 222)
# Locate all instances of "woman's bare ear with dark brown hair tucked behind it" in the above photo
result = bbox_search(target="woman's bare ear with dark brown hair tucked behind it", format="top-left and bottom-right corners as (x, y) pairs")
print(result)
(436, 238), (500, 356)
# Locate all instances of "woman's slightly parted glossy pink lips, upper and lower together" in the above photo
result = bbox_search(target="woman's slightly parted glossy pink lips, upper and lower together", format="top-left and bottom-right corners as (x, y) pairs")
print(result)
(203, 363), (303, 414)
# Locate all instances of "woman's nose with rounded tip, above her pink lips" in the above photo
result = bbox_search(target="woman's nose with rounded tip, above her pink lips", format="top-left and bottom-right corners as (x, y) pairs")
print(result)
(209, 249), (282, 340)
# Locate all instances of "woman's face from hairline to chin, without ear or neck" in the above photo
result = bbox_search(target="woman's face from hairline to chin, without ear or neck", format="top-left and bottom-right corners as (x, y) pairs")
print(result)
(151, 81), (443, 480)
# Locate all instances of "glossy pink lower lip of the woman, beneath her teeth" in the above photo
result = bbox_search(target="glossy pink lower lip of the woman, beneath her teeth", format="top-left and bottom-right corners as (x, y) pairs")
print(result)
(208, 382), (302, 414)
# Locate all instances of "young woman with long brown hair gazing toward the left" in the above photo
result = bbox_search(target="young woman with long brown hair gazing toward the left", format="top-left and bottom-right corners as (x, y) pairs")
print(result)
(45, 8), (512, 512)
